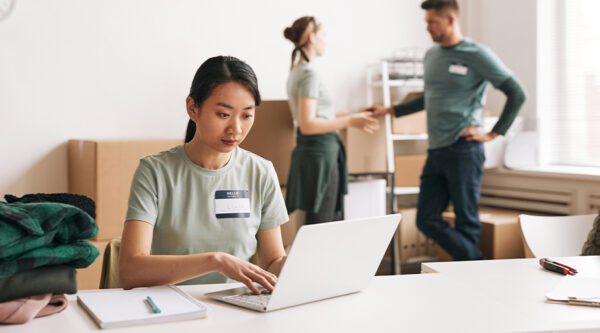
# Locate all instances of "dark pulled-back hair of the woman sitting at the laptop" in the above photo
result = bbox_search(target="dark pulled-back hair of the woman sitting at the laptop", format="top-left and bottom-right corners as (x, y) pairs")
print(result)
(185, 56), (260, 142)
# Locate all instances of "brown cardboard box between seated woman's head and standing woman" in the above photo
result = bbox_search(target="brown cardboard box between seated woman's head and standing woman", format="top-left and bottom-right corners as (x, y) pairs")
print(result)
(240, 100), (296, 185)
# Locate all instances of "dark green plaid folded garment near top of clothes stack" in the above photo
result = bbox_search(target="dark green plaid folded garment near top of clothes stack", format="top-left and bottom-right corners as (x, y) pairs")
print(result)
(0, 201), (99, 278)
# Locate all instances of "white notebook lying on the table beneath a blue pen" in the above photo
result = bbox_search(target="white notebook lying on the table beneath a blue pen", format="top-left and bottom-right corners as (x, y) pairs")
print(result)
(77, 286), (208, 328)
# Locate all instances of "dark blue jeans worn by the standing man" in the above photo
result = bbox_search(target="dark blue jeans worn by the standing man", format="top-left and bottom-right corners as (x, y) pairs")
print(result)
(417, 138), (485, 260)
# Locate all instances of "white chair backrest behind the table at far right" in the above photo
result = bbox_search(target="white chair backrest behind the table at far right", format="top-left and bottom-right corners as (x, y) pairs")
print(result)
(519, 214), (596, 258)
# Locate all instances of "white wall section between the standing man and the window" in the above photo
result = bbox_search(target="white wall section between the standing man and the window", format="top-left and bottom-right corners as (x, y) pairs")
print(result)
(460, 0), (537, 129)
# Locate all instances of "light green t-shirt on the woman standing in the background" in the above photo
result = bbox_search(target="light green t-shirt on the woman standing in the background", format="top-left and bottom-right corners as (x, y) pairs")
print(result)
(287, 63), (335, 124)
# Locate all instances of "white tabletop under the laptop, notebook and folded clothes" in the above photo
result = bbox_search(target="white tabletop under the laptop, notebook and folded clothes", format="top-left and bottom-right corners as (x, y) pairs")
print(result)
(7, 257), (600, 333)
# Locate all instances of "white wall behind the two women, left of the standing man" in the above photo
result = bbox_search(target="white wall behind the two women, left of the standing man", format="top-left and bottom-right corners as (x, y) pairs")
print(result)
(0, 0), (431, 199)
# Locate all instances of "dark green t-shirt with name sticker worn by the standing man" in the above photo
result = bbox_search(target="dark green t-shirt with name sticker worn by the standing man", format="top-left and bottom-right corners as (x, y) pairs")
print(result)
(423, 38), (512, 149)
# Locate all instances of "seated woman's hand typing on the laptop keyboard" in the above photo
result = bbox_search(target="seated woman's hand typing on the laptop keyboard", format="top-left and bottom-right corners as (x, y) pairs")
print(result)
(216, 252), (277, 295)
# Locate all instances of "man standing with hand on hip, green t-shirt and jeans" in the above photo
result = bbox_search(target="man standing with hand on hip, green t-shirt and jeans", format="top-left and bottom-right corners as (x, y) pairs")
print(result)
(367, 0), (525, 260)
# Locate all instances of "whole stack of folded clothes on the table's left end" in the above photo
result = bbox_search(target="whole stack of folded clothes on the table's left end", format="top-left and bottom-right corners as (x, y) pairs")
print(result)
(0, 193), (99, 324)
